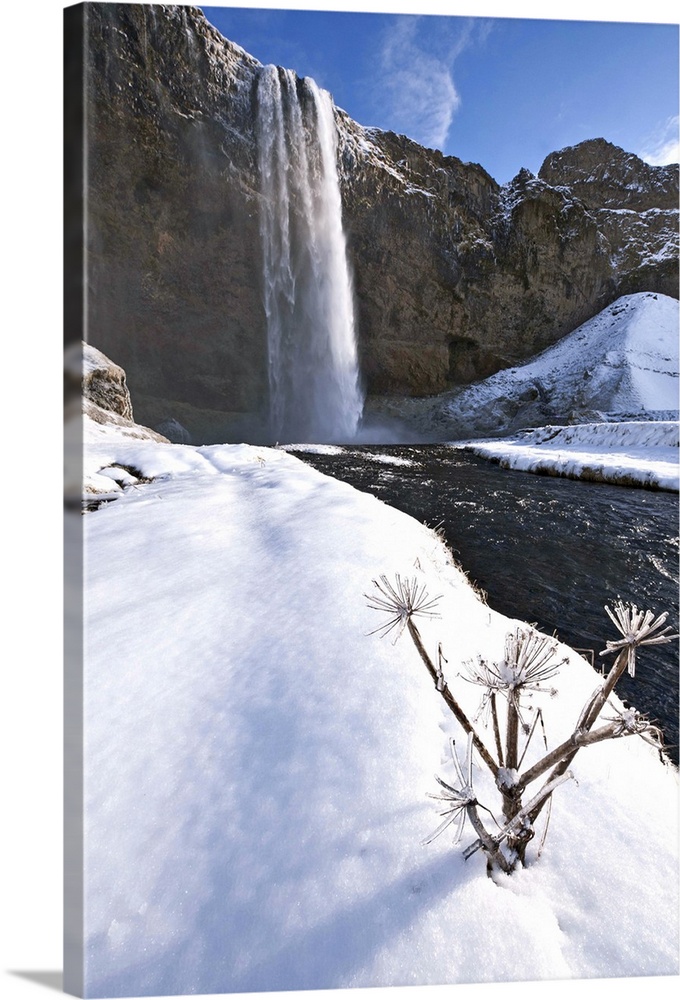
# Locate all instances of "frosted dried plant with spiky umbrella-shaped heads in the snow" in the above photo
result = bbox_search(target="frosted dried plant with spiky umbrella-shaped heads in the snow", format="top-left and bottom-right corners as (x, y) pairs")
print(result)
(365, 576), (678, 873)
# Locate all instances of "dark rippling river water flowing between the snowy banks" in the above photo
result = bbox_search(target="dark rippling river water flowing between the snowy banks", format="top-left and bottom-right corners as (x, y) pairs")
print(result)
(296, 445), (678, 764)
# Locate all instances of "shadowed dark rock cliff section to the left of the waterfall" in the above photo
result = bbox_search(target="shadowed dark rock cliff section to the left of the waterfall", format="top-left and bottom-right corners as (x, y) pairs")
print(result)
(85, 4), (266, 438)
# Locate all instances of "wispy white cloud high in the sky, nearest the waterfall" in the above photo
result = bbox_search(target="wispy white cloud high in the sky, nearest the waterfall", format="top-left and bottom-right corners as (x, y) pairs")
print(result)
(374, 15), (488, 149)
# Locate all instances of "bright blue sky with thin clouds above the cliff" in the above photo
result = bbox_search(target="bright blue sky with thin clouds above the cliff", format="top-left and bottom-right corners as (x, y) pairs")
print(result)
(201, 4), (678, 183)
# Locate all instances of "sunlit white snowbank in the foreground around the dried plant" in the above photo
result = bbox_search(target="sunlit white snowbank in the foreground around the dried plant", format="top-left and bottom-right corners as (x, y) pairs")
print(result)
(84, 418), (678, 996)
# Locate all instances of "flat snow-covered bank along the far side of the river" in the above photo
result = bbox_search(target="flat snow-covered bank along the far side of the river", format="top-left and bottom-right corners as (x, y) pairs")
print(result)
(452, 420), (680, 491)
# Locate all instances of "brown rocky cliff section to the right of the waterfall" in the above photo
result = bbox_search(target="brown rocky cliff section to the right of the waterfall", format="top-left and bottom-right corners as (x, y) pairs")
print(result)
(342, 129), (678, 394)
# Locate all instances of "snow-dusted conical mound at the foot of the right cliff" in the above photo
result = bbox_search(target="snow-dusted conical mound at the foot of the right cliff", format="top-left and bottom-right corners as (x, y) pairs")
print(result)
(436, 292), (679, 437)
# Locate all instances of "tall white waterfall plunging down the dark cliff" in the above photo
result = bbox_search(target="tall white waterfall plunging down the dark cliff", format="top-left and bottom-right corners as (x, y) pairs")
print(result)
(257, 66), (363, 442)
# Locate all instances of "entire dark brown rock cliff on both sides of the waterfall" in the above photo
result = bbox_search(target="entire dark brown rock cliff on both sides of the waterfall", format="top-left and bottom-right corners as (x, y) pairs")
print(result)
(74, 3), (678, 439)
